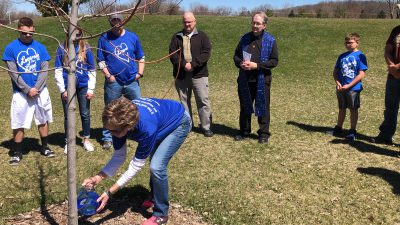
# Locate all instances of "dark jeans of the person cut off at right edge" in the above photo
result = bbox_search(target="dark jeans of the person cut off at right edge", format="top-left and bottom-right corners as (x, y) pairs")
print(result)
(379, 76), (400, 140)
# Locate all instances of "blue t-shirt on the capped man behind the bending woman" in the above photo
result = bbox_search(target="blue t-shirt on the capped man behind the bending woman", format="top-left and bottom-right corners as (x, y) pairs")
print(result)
(97, 29), (144, 85)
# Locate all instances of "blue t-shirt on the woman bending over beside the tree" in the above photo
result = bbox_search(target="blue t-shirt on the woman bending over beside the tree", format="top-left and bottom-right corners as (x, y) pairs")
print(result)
(113, 98), (185, 159)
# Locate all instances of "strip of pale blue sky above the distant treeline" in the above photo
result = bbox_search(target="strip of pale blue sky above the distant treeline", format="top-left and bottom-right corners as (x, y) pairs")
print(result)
(12, 0), (323, 12)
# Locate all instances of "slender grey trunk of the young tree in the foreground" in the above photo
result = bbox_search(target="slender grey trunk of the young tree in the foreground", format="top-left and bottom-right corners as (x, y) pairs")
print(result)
(67, 0), (79, 225)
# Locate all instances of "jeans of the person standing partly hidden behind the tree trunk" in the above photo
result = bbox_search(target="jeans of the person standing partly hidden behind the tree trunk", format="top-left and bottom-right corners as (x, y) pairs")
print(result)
(61, 87), (90, 138)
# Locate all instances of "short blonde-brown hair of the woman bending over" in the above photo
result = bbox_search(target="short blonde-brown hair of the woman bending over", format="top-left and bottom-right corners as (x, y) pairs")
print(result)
(102, 97), (139, 130)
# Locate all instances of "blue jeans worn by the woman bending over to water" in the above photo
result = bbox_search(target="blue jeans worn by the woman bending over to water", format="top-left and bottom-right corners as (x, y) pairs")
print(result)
(150, 111), (192, 216)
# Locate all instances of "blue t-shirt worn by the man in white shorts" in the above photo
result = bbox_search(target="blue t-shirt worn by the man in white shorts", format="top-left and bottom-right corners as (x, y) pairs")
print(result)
(3, 39), (51, 92)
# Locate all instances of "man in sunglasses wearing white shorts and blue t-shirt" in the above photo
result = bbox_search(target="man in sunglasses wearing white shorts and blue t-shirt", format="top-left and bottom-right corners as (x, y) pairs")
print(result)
(3, 17), (55, 165)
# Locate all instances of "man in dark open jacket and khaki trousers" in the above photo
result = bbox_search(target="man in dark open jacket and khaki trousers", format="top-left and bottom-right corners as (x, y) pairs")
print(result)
(169, 12), (213, 137)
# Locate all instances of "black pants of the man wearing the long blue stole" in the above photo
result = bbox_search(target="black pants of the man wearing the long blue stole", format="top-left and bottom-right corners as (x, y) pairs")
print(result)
(238, 76), (271, 138)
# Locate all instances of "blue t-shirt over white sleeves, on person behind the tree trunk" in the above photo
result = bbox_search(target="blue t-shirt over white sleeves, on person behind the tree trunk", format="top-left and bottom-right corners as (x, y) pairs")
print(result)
(54, 45), (95, 90)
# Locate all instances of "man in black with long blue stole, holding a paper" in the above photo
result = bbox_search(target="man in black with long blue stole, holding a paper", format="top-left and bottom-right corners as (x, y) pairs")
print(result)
(233, 12), (278, 144)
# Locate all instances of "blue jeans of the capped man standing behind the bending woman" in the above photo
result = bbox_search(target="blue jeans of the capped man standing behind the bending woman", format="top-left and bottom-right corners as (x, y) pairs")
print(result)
(101, 80), (140, 142)
